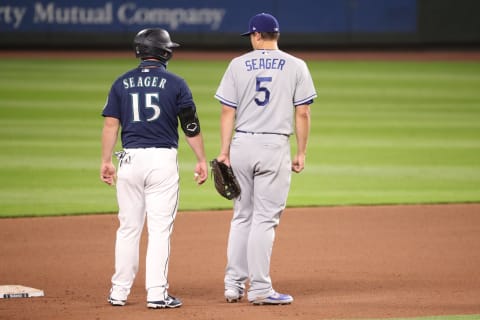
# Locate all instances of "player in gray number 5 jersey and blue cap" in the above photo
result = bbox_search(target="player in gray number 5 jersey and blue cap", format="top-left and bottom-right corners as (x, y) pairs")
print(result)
(215, 13), (317, 305)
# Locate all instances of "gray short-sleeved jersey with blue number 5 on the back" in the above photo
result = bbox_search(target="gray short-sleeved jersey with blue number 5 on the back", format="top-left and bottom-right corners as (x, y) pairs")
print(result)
(215, 50), (317, 135)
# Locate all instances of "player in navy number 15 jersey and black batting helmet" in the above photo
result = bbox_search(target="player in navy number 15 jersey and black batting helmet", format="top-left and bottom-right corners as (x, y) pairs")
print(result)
(100, 29), (207, 309)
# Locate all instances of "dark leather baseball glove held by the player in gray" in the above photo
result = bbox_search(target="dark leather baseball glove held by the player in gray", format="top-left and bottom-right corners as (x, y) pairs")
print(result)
(210, 159), (240, 200)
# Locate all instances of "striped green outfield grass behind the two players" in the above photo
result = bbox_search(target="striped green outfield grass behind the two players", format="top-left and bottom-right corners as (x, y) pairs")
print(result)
(0, 58), (480, 216)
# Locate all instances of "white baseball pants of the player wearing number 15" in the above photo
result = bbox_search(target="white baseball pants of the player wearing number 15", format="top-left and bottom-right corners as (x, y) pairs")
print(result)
(111, 148), (179, 301)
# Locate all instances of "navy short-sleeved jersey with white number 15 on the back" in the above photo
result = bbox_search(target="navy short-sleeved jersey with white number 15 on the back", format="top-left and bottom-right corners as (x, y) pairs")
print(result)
(102, 61), (195, 148)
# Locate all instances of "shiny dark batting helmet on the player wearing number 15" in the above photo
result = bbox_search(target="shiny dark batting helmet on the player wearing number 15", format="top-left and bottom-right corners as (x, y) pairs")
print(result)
(133, 28), (180, 62)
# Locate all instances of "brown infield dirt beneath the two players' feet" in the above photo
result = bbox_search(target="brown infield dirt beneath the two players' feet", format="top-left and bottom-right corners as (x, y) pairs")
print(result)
(0, 204), (480, 320)
